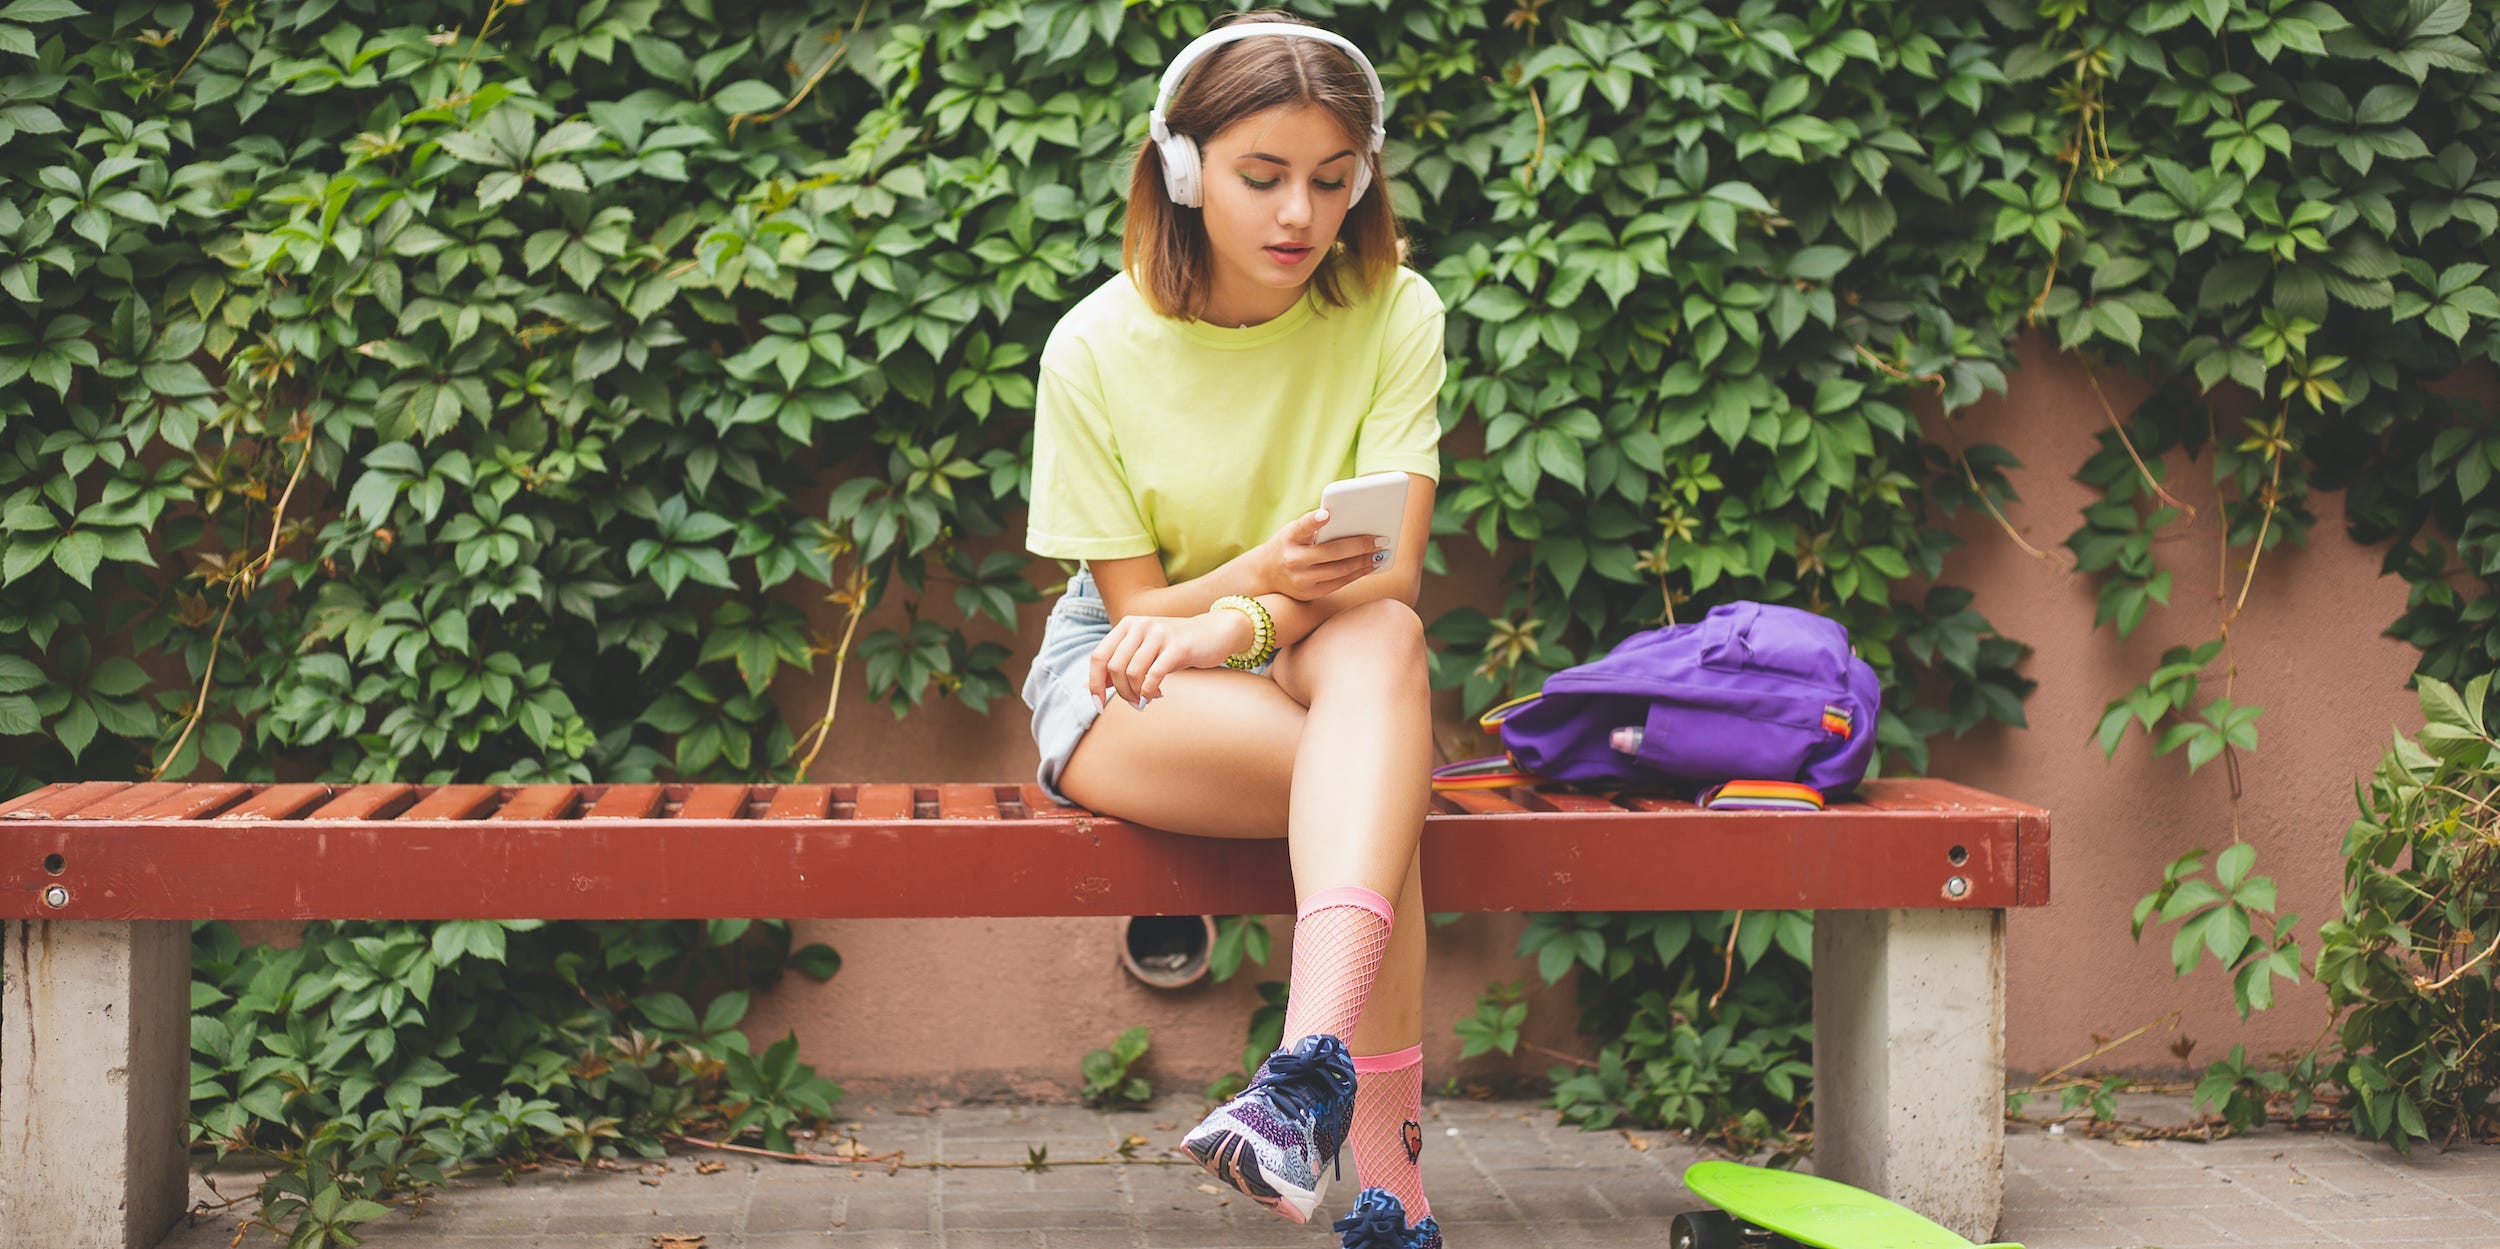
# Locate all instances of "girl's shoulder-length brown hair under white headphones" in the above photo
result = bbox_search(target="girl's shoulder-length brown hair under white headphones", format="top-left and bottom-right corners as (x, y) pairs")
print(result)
(1120, 10), (1405, 320)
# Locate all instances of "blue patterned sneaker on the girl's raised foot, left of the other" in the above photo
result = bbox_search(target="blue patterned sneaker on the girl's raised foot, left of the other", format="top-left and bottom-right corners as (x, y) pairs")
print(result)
(1180, 1032), (1355, 1224)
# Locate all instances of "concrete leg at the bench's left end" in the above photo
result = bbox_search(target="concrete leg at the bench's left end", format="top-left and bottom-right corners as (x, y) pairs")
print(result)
(0, 919), (190, 1249)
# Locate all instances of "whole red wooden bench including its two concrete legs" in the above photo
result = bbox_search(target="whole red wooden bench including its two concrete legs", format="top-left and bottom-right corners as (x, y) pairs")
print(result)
(0, 779), (2048, 1249)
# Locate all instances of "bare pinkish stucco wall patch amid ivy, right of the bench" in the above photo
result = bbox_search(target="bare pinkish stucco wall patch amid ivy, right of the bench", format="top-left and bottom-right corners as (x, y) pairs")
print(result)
(1930, 340), (2423, 1072)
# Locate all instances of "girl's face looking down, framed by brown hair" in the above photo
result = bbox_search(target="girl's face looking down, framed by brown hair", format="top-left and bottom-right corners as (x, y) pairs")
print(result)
(1200, 105), (1363, 325)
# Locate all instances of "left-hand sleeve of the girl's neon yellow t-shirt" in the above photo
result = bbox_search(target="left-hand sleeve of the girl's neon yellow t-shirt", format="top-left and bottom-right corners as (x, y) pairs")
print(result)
(1025, 352), (1155, 560)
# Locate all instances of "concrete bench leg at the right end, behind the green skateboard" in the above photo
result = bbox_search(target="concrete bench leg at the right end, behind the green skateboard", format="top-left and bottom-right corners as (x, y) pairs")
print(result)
(1815, 909), (2005, 1242)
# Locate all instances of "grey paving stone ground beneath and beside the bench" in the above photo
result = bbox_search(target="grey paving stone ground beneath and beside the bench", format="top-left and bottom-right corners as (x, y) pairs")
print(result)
(160, 1097), (2500, 1249)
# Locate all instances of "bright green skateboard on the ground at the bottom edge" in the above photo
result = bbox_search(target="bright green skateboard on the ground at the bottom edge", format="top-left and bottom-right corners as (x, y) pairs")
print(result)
(1673, 1162), (2023, 1249)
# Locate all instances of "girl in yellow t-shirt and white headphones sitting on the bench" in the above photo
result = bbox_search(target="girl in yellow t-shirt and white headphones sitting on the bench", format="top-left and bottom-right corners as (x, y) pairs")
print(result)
(1025, 12), (1443, 1249)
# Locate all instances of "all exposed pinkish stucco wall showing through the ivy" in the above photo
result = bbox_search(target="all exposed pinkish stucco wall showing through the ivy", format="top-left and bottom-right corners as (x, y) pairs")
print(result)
(753, 342), (2420, 1094)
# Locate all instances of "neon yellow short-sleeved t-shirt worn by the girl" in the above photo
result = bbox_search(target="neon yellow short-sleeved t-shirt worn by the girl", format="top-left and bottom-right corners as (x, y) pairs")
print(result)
(1025, 267), (1445, 585)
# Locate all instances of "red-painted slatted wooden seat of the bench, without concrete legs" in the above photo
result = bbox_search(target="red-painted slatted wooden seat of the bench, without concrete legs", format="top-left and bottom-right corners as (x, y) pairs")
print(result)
(0, 782), (2048, 919)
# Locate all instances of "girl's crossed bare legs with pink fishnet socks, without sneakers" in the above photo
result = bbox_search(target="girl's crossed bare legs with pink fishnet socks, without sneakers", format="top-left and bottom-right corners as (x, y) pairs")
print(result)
(1060, 600), (1433, 1222)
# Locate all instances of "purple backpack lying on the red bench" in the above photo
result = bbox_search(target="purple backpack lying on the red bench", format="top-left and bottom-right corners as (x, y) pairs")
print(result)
(1485, 602), (1883, 797)
